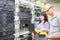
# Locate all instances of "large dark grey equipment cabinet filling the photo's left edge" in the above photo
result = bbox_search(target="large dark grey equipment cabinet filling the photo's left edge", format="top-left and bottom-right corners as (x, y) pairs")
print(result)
(0, 0), (15, 40)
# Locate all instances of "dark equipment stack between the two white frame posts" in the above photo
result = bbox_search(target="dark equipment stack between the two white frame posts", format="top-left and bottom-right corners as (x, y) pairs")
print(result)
(18, 5), (34, 32)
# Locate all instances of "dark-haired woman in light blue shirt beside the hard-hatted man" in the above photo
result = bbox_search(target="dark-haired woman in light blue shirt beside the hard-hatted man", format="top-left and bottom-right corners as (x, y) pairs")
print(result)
(32, 12), (49, 40)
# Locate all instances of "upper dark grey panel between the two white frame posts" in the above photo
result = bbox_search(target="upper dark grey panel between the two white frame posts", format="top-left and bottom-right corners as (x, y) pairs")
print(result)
(18, 6), (32, 19)
